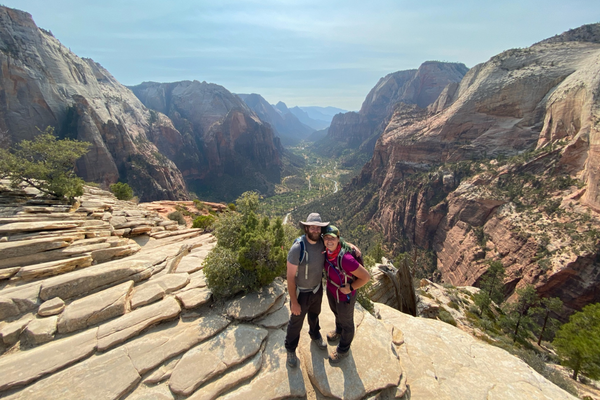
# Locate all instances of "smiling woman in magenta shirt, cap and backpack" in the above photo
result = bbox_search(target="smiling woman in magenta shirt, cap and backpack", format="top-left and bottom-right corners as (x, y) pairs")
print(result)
(323, 225), (371, 364)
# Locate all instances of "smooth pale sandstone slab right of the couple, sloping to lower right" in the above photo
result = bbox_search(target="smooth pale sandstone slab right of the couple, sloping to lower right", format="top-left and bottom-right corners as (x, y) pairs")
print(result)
(377, 304), (575, 400)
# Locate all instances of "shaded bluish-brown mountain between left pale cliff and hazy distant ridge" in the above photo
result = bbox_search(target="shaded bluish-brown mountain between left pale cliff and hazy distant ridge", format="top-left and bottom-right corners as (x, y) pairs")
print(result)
(131, 81), (283, 199)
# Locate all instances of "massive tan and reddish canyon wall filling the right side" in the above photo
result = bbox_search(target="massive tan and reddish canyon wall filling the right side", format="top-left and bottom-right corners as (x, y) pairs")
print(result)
(292, 24), (600, 315)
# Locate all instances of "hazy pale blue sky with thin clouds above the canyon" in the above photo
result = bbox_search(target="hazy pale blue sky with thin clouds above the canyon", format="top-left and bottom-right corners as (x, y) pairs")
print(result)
(0, 0), (600, 110)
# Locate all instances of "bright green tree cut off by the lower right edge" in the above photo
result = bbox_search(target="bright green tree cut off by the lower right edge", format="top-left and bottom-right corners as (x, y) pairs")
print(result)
(552, 303), (600, 379)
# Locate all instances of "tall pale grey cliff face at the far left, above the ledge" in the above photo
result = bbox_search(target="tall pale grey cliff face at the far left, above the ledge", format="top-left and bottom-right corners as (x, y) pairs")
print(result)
(0, 7), (187, 200)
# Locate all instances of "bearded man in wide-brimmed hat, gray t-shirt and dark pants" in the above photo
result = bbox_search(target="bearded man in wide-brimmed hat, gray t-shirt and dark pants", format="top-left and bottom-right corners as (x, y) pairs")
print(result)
(285, 213), (329, 368)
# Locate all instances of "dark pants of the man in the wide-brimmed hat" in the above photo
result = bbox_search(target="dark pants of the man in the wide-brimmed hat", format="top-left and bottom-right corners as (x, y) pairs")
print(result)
(285, 285), (323, 351)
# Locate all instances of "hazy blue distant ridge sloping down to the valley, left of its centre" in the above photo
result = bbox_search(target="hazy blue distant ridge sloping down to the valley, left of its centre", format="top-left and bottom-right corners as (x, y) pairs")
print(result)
(238, 93), (314, 146)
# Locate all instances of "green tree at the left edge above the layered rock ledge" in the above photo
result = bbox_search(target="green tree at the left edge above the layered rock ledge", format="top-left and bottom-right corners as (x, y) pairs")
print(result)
(0, 127), (90, 199)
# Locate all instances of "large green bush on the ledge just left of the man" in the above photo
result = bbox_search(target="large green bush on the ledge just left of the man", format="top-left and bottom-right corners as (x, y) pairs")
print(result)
(204, 192), (298, 298)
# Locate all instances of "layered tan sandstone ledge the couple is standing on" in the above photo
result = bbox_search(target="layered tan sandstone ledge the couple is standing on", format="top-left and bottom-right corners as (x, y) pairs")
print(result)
(0, 183), (573, 400)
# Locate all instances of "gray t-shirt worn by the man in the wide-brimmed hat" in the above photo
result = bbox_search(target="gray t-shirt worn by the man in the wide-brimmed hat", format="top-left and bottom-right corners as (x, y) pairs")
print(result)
(288, 239), (325, 289)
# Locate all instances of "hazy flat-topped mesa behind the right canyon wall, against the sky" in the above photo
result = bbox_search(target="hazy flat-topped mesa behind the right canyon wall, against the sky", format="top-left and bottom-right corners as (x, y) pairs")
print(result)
(318, 61), (468, 156)
